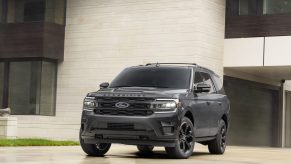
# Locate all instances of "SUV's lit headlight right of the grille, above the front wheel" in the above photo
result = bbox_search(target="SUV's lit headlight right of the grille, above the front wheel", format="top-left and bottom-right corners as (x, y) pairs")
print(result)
(151, 99), (178, 111)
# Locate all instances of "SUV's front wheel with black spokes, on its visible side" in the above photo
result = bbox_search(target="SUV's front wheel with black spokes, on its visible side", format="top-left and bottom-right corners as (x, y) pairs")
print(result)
(165, 117), (195, 159)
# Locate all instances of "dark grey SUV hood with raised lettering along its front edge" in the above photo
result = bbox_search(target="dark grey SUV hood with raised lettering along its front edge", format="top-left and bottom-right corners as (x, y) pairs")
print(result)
(87, 87), (187, 98)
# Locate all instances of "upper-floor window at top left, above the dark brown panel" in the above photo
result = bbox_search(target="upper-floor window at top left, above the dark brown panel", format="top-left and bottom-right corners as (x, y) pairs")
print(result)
(7, 0), (66, 24)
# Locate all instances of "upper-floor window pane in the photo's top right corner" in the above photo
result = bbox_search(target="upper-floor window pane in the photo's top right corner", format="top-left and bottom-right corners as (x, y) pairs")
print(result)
(264, 0), (291, 14)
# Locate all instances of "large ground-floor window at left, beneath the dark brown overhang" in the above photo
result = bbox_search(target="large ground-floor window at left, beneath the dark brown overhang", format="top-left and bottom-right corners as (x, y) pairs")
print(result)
(0, 61), (57, 116)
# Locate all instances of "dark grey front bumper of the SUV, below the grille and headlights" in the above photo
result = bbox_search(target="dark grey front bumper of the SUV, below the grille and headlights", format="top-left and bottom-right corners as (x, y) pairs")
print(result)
(80, 110), (181, 146)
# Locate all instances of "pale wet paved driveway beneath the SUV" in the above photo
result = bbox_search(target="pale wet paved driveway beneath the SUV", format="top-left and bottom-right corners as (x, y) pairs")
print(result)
(0, 144), (291, 164)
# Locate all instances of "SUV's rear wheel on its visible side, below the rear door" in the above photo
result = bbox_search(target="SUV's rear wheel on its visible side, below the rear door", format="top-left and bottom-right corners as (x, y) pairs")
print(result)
(208, 120), (227, 154)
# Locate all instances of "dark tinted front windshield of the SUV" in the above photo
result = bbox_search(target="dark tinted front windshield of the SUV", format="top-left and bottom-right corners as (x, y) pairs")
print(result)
(110, 67), (191, 89)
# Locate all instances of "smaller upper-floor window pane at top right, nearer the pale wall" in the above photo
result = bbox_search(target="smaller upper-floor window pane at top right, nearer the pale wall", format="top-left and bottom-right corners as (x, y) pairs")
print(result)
(239, 0), (257, 15)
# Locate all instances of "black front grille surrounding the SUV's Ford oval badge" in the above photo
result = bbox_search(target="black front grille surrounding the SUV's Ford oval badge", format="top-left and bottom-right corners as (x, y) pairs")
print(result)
(94, 97), (154, 116)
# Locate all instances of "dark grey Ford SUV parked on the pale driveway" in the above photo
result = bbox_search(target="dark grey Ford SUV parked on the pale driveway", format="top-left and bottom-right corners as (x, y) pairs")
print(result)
(80, 63), (230, 158)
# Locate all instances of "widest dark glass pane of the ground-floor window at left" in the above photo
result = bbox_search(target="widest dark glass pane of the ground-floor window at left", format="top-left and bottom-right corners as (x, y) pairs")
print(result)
(8, 61), (41, 115)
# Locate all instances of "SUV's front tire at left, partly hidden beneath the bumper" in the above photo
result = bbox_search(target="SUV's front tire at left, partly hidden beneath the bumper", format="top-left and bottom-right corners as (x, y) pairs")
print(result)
(79, 129), (111, 157)
